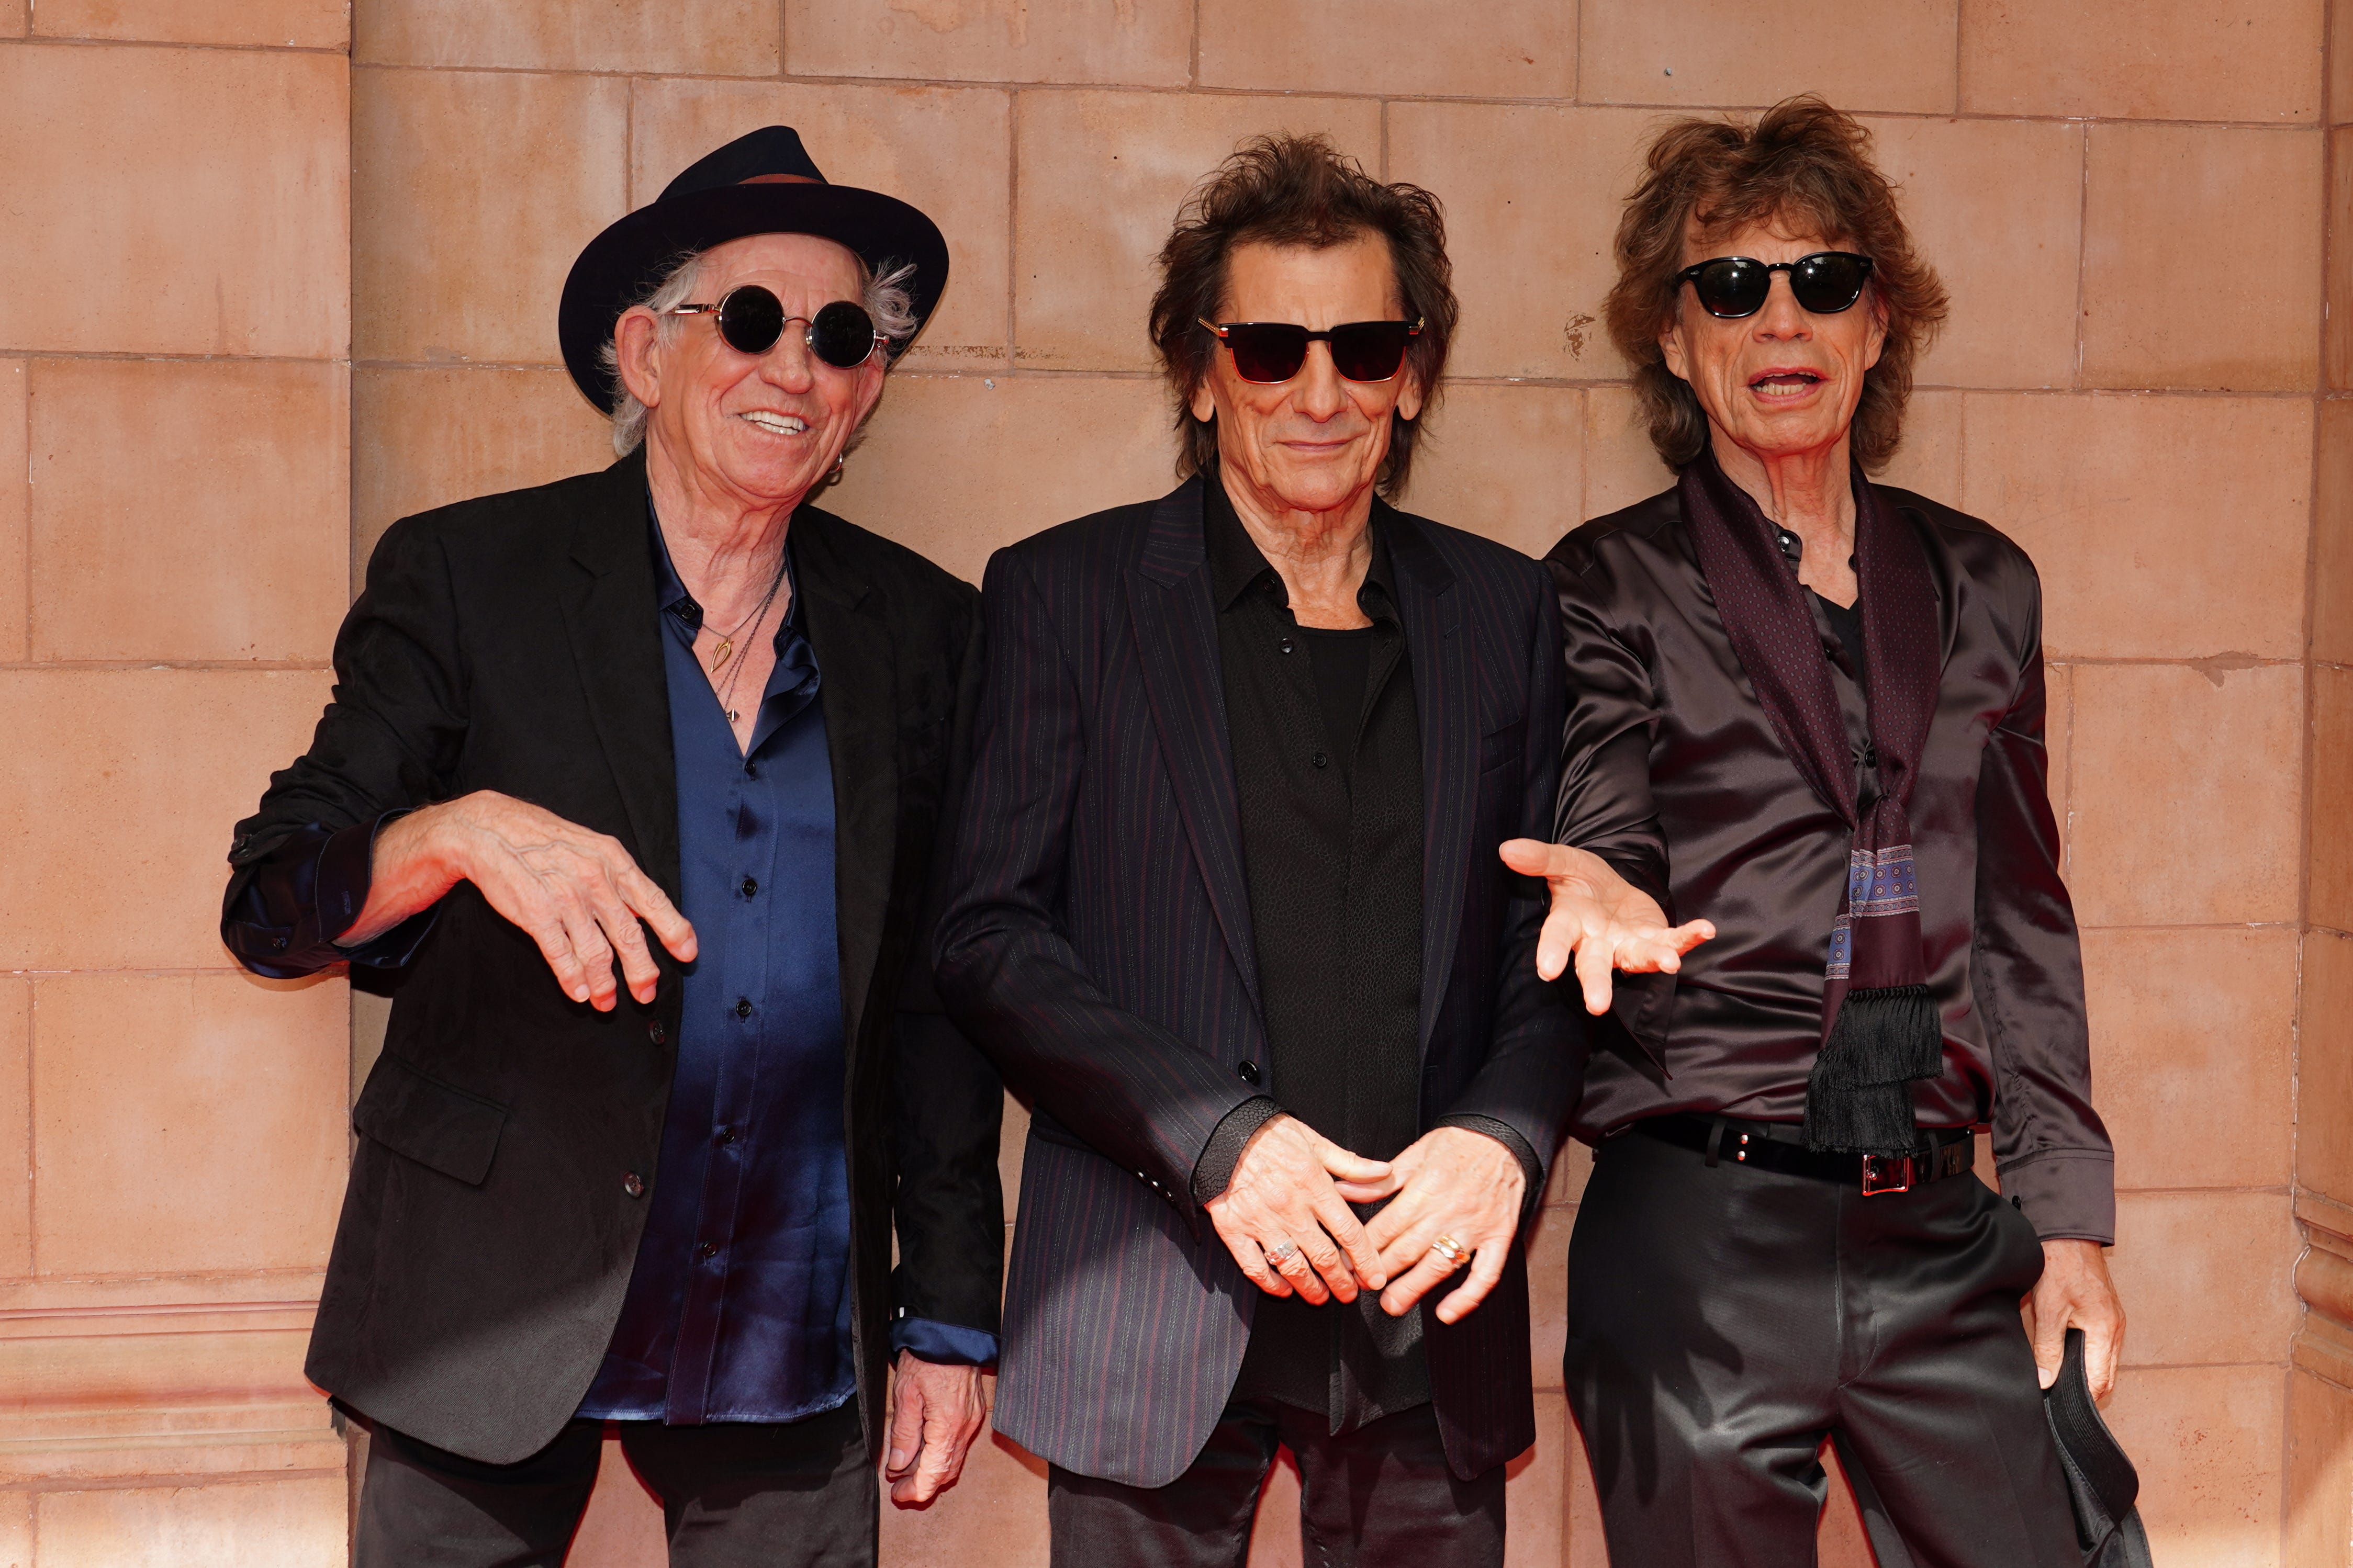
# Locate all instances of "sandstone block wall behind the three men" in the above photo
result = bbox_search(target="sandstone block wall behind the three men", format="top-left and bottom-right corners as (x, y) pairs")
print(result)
(0, 0), (2353, 1568)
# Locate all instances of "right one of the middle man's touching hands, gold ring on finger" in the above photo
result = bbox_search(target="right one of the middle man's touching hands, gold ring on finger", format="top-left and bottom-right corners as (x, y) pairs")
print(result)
(1358, 1126), (1527, 1324)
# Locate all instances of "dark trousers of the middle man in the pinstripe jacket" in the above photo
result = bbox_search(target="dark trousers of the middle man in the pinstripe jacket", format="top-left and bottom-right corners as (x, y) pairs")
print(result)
(1047, 1398), (1504, 1568)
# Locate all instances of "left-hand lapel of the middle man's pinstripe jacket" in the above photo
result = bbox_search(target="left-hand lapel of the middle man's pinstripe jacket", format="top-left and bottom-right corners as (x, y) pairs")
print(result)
(1127, 475), (1259, 1004)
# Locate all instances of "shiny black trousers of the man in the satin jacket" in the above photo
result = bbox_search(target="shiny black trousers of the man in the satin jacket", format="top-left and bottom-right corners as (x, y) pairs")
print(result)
(1567, 1133), (2082, 1568)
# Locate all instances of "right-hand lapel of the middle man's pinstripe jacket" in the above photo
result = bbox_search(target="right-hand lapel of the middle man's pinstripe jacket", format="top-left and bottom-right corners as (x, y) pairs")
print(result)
(1374, 501), (1477, 1053)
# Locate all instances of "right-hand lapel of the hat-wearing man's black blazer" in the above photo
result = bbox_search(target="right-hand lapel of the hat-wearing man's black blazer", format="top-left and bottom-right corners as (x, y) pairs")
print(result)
(793, 508), (899, 1048)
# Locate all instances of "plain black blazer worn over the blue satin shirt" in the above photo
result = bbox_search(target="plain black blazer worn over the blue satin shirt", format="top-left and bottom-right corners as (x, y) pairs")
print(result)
(223, 456), (1005, 1462)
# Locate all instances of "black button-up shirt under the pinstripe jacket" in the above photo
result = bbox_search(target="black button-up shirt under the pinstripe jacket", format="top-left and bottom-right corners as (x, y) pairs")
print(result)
(1195, 475), (1534, 1431)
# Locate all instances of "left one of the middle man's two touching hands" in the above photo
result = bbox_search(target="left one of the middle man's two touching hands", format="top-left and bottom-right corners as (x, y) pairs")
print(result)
(1207, 1116), (1393, 1307)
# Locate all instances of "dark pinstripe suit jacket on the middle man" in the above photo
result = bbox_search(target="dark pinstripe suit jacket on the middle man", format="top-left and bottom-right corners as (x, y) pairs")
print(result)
(936, 477), (1586, 1486)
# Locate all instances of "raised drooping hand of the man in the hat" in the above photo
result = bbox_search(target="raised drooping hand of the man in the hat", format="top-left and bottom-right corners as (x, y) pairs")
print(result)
(334, 790), (694, 1013)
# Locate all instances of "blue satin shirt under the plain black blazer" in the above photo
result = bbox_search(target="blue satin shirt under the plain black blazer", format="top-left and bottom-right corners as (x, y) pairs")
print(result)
(579, 508), (998, 1425)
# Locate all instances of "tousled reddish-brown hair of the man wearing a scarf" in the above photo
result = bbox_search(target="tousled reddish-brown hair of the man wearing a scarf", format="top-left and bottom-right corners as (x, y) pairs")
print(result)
(1603, 94), (1946, 472)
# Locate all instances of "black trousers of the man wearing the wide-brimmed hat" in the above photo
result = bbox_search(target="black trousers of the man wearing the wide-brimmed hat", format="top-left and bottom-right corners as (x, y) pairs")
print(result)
(351, 1401), (882, 1568)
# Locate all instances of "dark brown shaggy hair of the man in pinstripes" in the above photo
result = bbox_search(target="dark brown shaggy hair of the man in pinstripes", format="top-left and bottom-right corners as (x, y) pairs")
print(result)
(1151, 134), (1461, 496)
